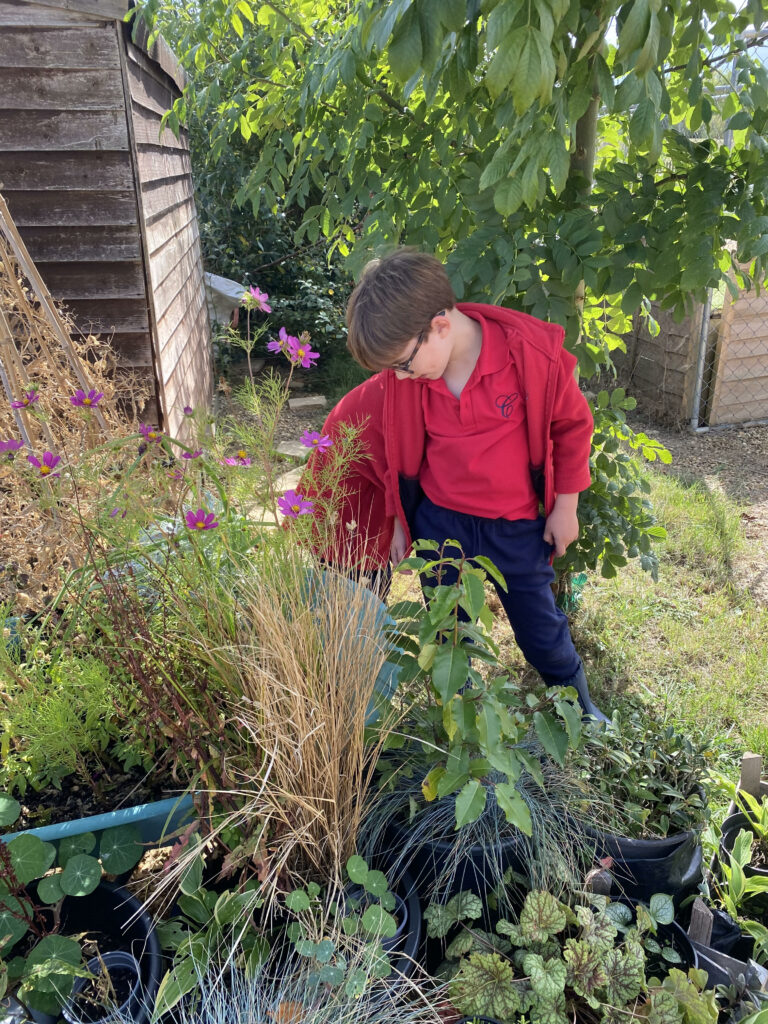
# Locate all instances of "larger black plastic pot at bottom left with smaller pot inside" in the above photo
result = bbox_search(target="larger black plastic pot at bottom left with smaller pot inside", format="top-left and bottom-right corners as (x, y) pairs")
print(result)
(61, 882), (164, 1024)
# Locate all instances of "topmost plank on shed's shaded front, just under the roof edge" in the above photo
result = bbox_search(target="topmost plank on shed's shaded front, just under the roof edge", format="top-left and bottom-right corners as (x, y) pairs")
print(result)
(0, 24), (120, 70)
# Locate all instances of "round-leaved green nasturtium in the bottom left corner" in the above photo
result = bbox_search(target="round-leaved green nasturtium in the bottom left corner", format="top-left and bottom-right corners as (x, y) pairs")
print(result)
(0, 794), (143, 1014)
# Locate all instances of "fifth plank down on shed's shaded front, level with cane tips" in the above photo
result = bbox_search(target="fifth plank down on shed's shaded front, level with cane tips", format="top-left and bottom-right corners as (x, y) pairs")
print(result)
(6, 191), (137, 227)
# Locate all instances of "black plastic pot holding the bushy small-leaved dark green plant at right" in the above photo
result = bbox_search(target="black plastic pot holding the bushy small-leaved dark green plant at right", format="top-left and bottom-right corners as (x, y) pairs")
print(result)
(590, 829), (703, 906)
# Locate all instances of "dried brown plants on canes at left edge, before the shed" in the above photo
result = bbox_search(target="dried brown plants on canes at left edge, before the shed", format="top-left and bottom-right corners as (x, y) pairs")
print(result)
(0, 225), (151, 611)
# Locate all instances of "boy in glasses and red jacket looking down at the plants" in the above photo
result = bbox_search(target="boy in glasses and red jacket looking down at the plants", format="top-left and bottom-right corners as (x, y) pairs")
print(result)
(303, 250), (606, 720)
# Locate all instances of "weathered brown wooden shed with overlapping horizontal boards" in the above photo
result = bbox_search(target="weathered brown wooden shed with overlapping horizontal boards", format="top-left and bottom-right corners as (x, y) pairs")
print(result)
(0, 0), (212, 435)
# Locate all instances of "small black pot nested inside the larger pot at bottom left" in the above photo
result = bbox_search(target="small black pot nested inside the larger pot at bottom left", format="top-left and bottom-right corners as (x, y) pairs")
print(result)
(61, 949), (143, 1024)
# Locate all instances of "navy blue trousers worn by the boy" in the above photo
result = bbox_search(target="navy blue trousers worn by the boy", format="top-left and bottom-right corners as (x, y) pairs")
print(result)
(413, 497), (582, 686)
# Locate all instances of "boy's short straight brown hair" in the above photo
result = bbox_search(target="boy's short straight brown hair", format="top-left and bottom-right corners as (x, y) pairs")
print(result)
(347, 249), (456, 370)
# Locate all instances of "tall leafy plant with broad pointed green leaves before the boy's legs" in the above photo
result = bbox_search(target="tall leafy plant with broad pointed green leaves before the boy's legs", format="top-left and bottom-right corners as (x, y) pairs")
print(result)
(382, 541), (582, 836)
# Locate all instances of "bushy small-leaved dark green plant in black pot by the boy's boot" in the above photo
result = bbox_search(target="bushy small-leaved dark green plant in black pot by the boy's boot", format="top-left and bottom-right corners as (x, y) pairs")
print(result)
(570, 711), (714, 839)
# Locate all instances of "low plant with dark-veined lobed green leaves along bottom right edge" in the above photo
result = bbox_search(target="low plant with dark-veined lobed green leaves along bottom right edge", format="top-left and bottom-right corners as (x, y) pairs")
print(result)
(434, 891), (718, 1024)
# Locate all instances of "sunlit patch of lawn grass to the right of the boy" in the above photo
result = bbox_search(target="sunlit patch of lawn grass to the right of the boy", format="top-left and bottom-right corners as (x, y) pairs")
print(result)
(572, 470), (768, 764)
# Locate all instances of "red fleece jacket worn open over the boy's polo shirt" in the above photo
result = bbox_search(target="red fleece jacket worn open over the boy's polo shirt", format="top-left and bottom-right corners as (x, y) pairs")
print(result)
(302, 302), (593, 571)
